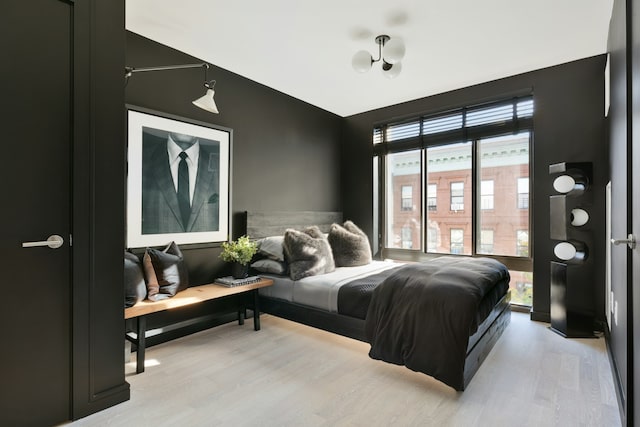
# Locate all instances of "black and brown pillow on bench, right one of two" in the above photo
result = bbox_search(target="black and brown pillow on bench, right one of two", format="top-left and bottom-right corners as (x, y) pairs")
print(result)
(142, 242), (189, 301)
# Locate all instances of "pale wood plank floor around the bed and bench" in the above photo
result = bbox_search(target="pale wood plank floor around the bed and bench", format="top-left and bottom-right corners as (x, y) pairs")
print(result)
(71, 313), (620, 427)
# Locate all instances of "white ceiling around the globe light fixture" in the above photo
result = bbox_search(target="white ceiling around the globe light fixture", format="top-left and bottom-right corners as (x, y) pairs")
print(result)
(126, 0), (613, 116)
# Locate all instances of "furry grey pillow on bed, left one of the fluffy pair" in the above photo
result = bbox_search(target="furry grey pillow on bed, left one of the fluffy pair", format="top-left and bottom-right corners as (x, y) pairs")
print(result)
(283, 226), (336, 280)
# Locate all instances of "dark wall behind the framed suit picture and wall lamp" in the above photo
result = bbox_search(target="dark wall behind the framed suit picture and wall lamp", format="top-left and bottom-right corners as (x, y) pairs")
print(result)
(125, 32), (342, 284)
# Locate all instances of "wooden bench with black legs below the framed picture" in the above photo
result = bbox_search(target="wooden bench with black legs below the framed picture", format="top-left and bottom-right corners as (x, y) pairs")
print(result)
(124, 279), (273, 374)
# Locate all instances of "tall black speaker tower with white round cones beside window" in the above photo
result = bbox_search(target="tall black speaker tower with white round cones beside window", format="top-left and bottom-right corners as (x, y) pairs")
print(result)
(549, 162), (594, 338)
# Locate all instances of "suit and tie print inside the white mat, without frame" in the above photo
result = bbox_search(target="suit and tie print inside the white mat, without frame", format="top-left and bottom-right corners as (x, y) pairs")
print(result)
(142, 132), (220, 234)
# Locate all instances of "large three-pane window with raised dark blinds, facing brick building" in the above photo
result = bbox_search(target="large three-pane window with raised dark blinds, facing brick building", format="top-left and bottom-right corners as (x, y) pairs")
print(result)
(372, 95), (534, 297)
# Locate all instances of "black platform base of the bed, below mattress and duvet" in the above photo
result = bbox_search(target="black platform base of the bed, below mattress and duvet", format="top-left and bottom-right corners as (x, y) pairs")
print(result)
(260, 291), (511, 388)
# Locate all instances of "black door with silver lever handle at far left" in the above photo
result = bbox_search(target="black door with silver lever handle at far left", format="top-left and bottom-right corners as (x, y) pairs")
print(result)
(0, 0), (73, 425)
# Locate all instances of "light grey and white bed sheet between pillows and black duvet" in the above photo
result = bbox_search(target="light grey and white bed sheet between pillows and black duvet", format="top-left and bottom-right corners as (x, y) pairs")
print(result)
(260, 261), (401, 313)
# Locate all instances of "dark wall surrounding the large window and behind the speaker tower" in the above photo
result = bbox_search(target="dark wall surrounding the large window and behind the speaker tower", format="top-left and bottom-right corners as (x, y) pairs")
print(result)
(342, 55), (608, 321)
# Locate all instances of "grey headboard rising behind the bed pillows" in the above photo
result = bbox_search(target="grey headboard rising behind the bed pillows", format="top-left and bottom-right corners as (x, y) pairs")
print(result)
(247, 211), (342, 239)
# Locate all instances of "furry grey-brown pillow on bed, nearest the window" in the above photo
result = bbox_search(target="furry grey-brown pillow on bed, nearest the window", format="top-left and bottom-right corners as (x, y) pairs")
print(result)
(328, 221), (371, 267)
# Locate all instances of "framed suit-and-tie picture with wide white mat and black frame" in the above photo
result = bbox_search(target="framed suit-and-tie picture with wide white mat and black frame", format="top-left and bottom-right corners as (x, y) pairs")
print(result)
(127, 106), (232, 248)
